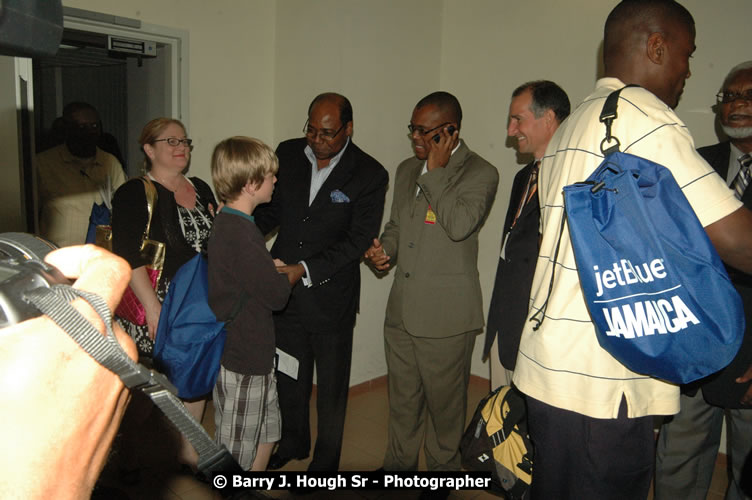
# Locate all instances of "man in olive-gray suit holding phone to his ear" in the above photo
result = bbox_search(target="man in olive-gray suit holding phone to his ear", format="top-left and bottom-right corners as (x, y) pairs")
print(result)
(365, 92), (499, 480)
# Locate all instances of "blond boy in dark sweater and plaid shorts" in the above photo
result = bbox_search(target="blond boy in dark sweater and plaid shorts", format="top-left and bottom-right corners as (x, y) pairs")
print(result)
(209, 137), (290, 471)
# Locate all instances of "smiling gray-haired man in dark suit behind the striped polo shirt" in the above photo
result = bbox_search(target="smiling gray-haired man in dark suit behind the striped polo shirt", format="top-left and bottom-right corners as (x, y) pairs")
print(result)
(483, 80), (569, 388)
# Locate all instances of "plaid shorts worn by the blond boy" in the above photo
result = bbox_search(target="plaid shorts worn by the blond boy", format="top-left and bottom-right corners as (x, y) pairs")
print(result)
(212, 366), (282, 470)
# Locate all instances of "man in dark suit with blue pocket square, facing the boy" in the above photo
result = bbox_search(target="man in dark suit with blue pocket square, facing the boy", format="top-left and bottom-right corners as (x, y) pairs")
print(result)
(254, 93), (389, 471)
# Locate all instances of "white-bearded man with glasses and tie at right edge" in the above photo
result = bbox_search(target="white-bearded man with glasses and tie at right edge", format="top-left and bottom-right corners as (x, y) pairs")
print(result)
(655, 61), (752, 499)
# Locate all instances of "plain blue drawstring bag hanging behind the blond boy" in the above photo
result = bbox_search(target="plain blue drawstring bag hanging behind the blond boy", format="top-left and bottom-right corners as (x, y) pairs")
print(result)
(152, 253), (225, 399)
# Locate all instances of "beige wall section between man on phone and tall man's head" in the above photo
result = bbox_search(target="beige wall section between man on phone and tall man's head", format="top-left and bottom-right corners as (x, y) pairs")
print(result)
(441, 0), (615, 346)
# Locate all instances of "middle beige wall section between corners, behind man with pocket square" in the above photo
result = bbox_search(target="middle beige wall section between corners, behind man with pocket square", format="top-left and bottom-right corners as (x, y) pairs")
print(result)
(274, 0), (441, 384)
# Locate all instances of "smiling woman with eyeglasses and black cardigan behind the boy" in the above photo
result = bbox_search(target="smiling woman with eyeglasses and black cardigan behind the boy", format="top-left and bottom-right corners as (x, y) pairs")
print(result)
(112, 118), (217, 479)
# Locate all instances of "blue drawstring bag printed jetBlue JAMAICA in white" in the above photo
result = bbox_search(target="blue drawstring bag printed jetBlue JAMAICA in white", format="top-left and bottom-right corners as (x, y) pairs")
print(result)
(564, 86), (744, 383)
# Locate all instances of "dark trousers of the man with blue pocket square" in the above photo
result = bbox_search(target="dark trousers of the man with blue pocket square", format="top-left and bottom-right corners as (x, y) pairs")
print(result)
(275, 309), (353, 471)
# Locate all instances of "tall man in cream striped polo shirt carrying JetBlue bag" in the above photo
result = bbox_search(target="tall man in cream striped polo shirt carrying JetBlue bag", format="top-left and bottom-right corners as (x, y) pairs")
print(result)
(514, 0), (752, 500)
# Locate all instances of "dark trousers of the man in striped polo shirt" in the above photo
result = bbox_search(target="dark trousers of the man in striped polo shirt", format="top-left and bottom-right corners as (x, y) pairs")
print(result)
(527, 397), (654, 500)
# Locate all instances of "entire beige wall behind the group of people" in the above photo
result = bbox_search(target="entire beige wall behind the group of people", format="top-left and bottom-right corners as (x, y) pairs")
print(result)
(55, 0), (752, 384)
